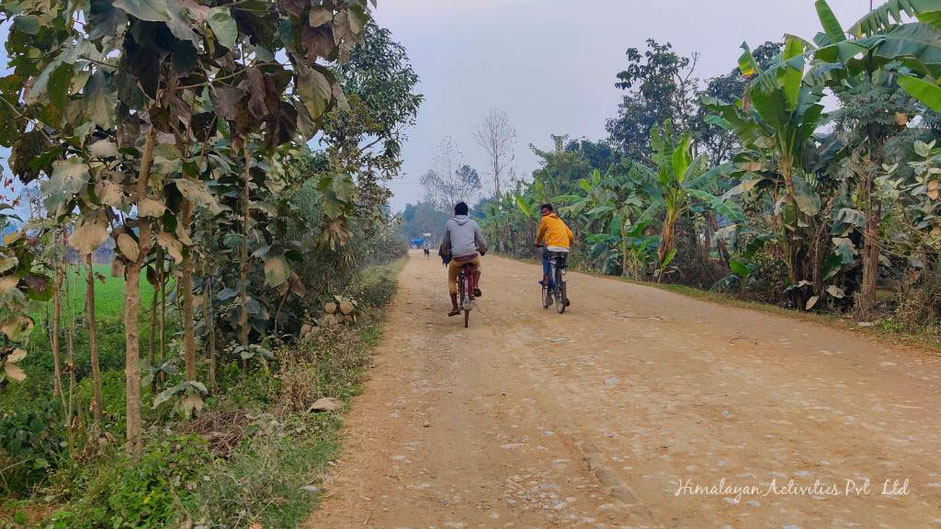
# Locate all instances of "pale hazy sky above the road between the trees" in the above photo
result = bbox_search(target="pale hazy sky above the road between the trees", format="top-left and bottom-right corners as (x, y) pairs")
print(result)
(374, 0), (869, 211)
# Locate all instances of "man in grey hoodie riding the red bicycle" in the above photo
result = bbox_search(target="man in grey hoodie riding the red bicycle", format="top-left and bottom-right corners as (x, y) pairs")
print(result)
(438, 202), (487, 316)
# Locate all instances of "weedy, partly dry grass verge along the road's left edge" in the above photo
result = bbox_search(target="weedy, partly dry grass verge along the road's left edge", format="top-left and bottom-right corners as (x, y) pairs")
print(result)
(0, 259), (405, 529)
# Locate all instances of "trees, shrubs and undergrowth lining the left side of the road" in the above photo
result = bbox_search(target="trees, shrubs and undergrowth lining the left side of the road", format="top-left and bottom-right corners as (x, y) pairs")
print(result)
(0, 0), (414, 529)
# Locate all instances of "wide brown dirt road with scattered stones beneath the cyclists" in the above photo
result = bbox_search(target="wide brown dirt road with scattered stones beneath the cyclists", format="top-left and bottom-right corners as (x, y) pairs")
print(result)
(306, 253), (941, 529)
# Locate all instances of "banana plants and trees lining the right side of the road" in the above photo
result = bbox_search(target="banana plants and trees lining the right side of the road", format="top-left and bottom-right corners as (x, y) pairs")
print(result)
(475, 0), (941, 341)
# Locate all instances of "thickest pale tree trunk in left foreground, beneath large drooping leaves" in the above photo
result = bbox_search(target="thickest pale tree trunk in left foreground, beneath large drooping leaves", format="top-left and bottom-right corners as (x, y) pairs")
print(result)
(124, 125), (157, 460)
